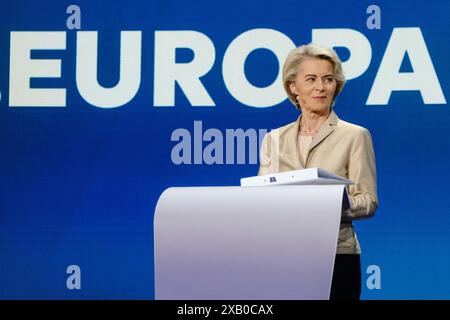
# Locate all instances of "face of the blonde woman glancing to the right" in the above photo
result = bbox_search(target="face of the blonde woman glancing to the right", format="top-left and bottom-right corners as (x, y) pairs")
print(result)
(290, 58), (336, 114)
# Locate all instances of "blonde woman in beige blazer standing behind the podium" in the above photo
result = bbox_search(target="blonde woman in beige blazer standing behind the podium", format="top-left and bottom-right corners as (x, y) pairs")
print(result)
(258, 44), (378, 299)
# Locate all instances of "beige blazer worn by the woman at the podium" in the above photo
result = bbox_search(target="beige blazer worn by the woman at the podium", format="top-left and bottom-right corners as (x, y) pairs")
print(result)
(258, 110), (378, 254)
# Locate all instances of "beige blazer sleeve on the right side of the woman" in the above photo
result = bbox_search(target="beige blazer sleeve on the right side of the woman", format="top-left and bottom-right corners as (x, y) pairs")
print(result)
(342, 128), (378, 221)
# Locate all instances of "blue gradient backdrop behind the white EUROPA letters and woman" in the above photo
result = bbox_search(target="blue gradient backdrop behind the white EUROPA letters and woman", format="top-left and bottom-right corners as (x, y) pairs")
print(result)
(0, 0), (450, 299)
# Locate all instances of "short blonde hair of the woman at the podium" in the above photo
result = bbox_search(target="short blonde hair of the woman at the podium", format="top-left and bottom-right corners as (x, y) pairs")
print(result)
(283, 43), (345, 108)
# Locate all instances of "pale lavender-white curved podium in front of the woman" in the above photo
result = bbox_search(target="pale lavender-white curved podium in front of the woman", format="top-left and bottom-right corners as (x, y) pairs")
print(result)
(154, 184), (345, 300)
